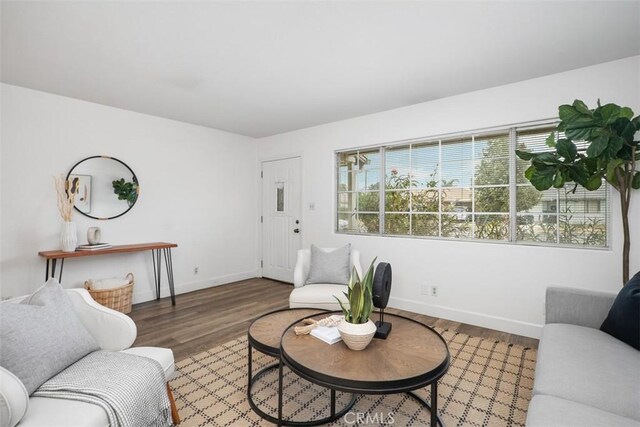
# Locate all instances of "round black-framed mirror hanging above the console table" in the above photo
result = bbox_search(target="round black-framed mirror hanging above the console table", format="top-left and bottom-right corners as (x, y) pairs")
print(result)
(67, 156), (140, 219)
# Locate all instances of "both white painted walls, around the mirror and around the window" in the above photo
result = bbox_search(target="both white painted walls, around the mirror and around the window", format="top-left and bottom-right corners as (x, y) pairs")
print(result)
(0, 57), (640, 336)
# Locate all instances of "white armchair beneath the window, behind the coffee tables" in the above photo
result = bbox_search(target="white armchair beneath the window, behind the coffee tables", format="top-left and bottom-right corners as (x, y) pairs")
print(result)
(289, 248), (362, 310)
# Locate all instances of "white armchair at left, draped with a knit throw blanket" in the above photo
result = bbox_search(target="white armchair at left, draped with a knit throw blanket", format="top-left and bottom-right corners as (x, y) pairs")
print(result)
(0, 289), (175, 427)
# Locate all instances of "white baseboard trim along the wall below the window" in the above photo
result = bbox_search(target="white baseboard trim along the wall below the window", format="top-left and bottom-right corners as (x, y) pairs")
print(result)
(389, 297), (542, 338)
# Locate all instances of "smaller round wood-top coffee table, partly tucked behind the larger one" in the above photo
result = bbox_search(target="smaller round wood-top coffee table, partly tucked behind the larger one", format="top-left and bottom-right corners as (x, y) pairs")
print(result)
(247, 308), (356, 426)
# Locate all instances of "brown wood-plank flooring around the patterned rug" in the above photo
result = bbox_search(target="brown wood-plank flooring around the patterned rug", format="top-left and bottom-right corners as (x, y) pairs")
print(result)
(130, 278), (538, 361)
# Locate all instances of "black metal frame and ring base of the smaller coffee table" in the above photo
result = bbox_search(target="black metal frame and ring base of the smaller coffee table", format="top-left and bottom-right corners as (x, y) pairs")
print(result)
(247, 308), (357, 427)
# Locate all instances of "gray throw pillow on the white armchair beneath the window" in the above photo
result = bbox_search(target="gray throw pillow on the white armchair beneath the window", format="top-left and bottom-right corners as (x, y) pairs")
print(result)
(307, 244), (351, 285)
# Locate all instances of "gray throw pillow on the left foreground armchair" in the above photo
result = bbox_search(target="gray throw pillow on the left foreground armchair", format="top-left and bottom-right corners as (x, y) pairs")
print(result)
(0, 279), (100, 395)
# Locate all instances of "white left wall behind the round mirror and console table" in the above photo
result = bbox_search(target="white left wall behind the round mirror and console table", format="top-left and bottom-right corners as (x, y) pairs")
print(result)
(0, 84), (258, 302)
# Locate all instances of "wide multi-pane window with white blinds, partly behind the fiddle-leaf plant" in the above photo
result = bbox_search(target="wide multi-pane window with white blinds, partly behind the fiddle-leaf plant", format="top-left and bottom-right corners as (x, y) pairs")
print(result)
(336, 125), (608, 247)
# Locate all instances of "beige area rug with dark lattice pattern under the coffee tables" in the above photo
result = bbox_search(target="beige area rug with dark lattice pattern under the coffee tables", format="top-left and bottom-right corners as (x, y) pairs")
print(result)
(171, 328), (536, 427)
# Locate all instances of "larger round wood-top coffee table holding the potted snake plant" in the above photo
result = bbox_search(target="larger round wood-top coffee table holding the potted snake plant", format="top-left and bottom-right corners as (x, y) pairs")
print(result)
(278, 312), (450, 427)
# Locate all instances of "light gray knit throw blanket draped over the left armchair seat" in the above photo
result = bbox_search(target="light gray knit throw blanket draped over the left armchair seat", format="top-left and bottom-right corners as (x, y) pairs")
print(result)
(33, 350), (172, 427)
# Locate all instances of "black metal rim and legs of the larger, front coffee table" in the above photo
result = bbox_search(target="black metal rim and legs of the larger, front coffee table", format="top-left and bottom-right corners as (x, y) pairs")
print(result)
(276, 315), (451, 427)
